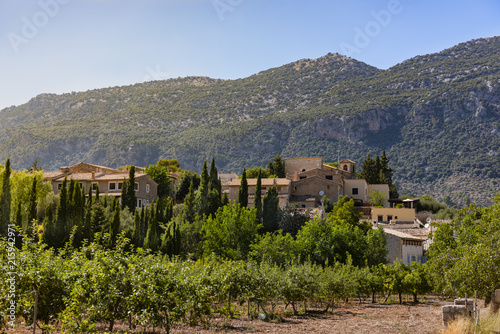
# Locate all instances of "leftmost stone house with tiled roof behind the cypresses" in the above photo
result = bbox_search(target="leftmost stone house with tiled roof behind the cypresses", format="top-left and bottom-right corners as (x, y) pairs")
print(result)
(44, 162), (158, 208)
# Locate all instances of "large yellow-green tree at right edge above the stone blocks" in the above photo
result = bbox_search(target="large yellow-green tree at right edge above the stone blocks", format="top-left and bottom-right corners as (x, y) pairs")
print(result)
(426, 194), (500, 302)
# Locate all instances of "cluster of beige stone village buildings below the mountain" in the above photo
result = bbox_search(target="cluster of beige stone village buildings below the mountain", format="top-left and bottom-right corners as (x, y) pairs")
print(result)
(44, 157), (432, 265)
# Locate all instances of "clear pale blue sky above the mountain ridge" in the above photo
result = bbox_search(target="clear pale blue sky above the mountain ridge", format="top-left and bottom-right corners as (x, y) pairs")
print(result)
(0, 0), (500, 109)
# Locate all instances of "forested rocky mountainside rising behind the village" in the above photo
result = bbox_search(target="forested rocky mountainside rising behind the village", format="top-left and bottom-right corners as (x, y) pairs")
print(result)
(0, 37), (500, 207)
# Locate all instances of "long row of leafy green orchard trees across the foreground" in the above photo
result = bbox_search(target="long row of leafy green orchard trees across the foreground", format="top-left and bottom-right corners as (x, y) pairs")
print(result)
(0, 235), (430, 333)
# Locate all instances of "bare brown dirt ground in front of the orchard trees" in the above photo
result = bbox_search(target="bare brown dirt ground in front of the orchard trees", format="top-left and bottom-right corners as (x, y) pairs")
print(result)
(7, 299), (453, 334)
